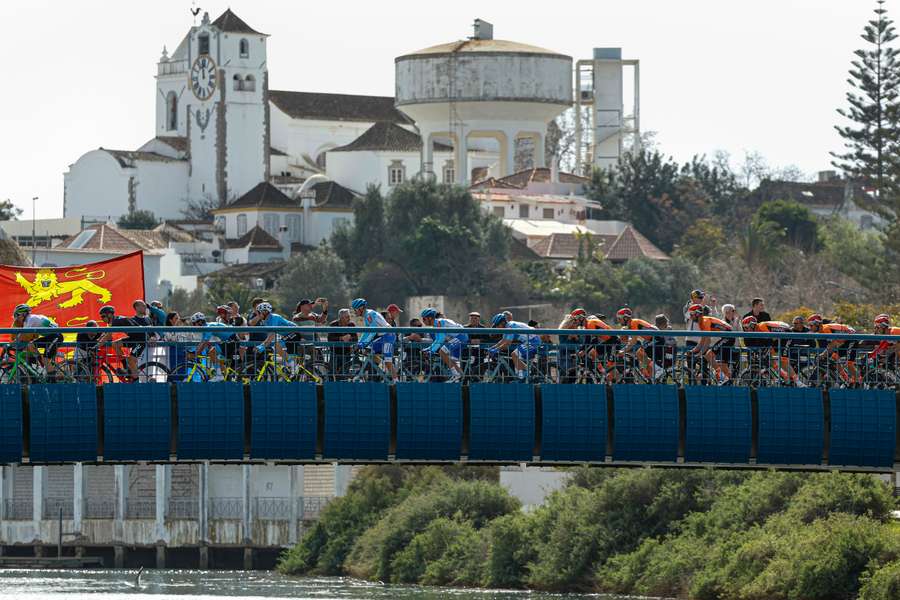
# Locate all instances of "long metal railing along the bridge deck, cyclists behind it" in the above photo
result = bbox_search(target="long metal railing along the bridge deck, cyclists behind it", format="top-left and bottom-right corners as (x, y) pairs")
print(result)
(0, 327), (900, 388)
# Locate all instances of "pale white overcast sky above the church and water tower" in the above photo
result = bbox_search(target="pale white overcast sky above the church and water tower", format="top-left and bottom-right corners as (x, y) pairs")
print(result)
(0, 0), (884, 219)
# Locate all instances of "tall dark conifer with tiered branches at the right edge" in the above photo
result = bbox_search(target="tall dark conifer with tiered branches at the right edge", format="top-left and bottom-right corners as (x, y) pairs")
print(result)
(832, 0), (900, 219)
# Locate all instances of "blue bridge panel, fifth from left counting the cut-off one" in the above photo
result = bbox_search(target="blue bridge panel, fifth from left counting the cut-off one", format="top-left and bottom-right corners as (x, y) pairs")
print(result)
(250, 381), (319, 459)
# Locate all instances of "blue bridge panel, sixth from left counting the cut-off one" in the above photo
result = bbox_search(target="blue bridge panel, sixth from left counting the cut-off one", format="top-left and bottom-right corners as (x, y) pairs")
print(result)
(324, 381), (391, 460)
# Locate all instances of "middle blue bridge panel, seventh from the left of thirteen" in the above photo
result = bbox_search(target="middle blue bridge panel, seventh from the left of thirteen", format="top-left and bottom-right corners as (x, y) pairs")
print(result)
(396, 383), (462, 460)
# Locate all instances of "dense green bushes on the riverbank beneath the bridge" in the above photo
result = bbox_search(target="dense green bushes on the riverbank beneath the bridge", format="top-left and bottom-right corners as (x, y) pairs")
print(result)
(279, 466), (900, 600)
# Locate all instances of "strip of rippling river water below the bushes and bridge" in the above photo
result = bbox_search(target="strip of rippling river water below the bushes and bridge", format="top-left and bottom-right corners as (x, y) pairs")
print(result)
(0, 569), (624, 600)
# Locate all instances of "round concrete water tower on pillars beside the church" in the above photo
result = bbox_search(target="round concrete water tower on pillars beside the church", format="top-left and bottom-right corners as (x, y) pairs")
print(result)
(394, 19), (572, 183)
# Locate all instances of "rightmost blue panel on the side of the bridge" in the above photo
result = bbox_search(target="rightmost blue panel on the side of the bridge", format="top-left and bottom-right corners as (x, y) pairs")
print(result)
(828, 390), (897, 467)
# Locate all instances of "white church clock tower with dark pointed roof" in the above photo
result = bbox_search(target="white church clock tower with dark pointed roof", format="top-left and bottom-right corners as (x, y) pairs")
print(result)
(181, 9), (269, 205)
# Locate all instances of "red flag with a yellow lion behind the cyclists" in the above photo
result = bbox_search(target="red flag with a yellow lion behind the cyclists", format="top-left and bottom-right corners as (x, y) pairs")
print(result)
(0, 251), (144, 327)
